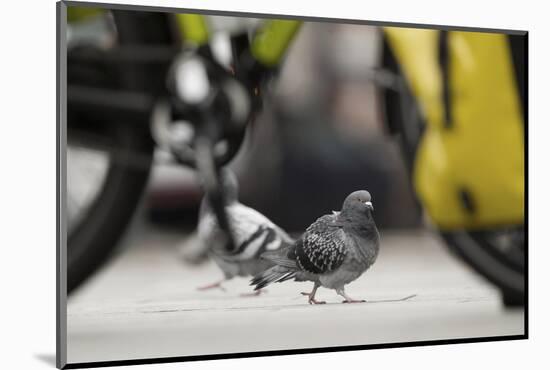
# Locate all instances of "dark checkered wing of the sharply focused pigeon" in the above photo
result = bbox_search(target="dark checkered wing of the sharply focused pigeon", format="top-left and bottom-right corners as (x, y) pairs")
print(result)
(292, 215), (347, 274)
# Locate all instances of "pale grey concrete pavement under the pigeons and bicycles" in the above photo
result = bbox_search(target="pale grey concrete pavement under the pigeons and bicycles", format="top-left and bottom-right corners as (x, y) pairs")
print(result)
(68, 225), (524, 362)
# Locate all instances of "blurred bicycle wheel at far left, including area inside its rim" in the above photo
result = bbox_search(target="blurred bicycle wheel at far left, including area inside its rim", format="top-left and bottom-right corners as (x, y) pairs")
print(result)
(67, 11), (179, 293)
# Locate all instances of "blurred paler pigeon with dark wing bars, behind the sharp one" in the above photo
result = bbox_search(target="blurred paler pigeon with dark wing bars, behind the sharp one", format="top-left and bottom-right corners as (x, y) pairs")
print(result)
(198, 169), (294, 290)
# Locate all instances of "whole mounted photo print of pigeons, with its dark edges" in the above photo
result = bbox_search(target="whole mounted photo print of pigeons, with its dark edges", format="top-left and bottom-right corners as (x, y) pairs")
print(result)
(57, 1), (528, 368)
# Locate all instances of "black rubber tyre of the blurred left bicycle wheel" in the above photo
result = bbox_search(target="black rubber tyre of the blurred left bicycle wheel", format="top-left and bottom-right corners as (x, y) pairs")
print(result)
(67, 11), (176, 294)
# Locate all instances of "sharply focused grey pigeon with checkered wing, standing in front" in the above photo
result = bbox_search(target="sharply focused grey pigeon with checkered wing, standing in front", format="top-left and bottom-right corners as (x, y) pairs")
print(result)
(251, 190), (380, 304)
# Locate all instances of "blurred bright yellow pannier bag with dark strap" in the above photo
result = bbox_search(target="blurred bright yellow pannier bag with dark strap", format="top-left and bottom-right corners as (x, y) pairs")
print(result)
(384, 28), (525, 230)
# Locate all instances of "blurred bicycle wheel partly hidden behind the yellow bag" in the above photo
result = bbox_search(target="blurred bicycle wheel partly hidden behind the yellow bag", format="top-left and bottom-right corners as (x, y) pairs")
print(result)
(382, 34), (525, 306)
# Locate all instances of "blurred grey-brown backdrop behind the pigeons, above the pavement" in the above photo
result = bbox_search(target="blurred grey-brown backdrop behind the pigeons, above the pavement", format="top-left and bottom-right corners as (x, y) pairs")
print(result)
(145, 23), (420, 232)
